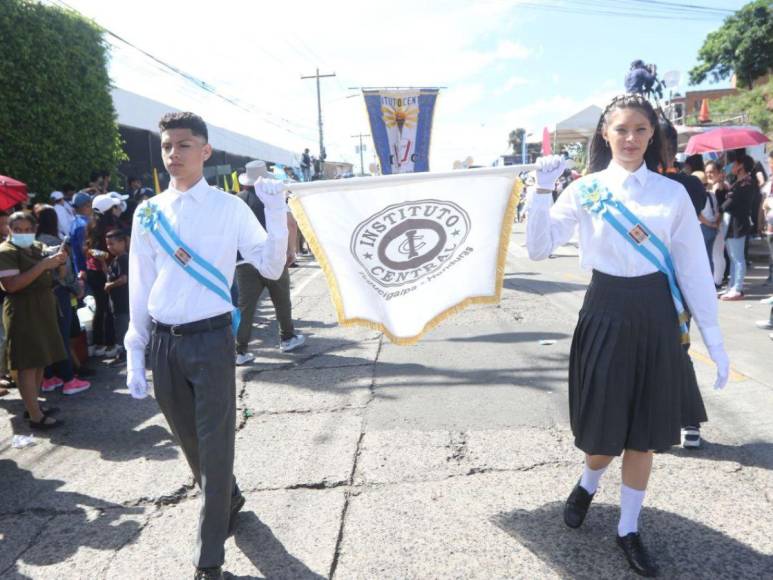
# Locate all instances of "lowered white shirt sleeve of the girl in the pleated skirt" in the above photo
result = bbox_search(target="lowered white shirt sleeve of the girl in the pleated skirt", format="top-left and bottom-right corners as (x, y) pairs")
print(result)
(671, 190), (722, 346)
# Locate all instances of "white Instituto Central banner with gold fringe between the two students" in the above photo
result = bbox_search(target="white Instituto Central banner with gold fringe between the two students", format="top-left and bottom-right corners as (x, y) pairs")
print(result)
(290, 166), (524, 344)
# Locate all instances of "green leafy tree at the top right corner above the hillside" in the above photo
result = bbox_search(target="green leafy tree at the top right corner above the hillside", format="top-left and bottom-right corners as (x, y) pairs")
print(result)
(690, 0), (773, 87)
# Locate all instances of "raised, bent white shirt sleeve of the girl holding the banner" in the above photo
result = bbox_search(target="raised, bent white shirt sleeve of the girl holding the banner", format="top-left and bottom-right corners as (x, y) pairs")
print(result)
(526, 184), (578, 260)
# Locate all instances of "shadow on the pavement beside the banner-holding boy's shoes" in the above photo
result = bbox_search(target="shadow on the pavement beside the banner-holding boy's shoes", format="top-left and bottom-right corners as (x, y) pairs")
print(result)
(226, 512), (324, 580)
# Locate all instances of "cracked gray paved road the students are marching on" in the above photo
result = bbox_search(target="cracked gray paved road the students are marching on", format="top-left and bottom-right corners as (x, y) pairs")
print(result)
(0, 226), (773, 579)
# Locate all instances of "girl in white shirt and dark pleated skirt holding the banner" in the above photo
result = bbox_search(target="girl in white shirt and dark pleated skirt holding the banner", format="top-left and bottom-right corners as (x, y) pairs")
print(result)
(527, 95), (729, 576)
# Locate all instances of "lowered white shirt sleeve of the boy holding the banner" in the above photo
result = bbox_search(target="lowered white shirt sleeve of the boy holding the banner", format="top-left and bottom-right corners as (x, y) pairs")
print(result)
(124, 206), (156, 364)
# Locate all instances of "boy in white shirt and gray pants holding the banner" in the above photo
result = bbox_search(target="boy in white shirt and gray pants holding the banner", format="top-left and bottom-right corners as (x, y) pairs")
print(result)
(125, 113), (287, 579)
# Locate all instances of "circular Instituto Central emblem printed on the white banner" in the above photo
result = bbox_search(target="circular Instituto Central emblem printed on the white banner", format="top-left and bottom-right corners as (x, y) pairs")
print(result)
(351, 199), (470, 287)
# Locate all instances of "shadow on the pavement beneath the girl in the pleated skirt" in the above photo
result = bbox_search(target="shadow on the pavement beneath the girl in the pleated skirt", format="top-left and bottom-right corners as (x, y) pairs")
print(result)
(492, 502), (773, 579)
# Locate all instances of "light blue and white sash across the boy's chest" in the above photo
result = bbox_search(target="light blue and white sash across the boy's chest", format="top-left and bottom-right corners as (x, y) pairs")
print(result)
(137, 202), (241, 334)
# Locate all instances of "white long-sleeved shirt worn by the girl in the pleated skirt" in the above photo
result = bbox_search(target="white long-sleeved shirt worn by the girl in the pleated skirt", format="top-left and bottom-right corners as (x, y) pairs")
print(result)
(526, 161), (722, 346)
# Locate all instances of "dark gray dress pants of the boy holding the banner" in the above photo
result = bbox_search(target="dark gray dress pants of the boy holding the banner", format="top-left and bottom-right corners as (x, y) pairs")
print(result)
(150, 324), (240, 568)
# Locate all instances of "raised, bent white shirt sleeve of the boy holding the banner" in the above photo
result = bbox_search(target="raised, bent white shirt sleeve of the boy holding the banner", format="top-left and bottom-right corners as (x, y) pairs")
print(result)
(236, 203), (288, 280)
